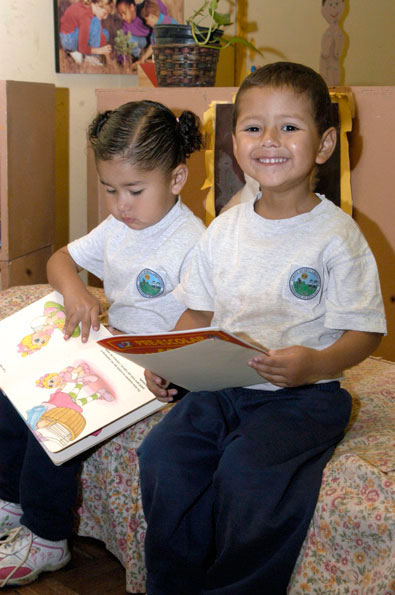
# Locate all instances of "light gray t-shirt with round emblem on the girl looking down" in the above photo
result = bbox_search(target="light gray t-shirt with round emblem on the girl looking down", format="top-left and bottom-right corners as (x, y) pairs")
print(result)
(67, 200), (205, 334)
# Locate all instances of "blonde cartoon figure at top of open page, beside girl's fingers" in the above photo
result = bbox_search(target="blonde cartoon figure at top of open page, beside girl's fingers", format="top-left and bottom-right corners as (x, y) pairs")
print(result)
(18, 302), (81, 357)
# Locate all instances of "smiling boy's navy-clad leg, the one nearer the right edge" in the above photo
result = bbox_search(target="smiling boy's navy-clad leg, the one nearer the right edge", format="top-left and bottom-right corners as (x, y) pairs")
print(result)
(202, 382), (351, 595)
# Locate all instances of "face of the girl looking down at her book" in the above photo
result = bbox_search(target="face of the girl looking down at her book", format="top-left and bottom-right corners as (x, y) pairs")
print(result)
(97, 157), (188, 230)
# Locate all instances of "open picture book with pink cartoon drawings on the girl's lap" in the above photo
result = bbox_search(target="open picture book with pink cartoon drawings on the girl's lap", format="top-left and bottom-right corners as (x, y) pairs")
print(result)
(0, 292), (163, 465)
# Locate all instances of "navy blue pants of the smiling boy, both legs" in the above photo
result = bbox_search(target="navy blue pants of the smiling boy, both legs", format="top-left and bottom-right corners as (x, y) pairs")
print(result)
(139, 382), (351, 595)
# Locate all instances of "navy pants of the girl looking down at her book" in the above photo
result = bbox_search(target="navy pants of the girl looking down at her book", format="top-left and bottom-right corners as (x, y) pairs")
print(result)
(0, 391), (81, 541)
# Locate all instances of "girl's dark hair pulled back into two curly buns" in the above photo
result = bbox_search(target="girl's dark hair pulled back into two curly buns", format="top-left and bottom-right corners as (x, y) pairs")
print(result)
(88, 100), (202, 173)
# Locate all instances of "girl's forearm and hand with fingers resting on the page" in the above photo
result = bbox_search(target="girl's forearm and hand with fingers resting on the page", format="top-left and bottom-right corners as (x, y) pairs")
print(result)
(47, 246), (101, 343)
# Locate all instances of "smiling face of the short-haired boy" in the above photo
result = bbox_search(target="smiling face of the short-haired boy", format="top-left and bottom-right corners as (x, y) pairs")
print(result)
(233, 87), (334, 198)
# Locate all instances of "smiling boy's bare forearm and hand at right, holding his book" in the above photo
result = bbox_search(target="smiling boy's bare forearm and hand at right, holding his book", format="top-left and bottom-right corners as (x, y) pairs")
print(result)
(249, 330), (382, 387)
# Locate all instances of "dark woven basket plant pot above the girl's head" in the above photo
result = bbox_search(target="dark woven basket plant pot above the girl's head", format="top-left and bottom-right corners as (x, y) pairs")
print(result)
(152, 24), (223, 87)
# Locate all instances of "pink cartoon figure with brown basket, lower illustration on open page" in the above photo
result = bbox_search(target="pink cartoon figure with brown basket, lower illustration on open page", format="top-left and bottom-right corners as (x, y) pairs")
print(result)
(27, 361), (115, 447)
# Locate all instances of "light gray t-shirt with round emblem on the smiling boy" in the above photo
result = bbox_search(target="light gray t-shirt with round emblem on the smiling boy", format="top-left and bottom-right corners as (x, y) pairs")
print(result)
(175, 195), (386, 386)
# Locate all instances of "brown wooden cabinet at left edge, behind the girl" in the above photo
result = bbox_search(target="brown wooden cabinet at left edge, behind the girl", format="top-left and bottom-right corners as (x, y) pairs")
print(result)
(0, 80), (55, 289)
